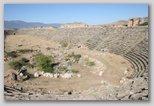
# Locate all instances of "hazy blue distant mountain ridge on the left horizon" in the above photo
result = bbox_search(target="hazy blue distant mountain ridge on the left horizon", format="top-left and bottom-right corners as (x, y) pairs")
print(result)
(4, 20), (61, 29)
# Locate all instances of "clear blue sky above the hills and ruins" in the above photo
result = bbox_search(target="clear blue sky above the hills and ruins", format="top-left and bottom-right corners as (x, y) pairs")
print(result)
(4, 4), (148, 25)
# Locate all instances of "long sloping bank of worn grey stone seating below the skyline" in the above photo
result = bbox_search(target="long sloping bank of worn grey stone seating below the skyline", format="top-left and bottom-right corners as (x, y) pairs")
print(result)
(17, 27), (148, 55)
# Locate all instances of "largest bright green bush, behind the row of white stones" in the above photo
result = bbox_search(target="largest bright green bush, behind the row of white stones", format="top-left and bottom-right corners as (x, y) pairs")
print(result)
(34, 53), (54, 73)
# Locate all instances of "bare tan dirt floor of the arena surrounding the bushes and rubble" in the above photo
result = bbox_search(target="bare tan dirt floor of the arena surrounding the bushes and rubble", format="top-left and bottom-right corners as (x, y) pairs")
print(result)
(4, 35), (134, 92)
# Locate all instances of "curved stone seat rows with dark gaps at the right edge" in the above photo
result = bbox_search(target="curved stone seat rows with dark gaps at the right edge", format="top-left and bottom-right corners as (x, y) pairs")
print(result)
(124, 51), (148, 77)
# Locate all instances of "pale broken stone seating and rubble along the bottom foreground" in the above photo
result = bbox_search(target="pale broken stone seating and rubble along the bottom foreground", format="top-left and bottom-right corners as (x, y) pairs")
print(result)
(4, 77), (148, 100)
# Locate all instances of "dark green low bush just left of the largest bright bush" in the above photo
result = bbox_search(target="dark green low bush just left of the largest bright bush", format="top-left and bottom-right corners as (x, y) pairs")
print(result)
(9, 58), (30, 70)
